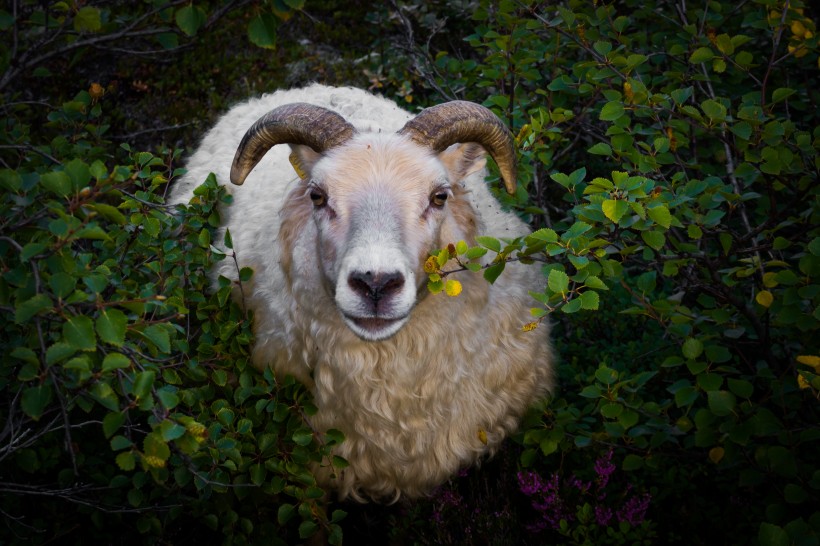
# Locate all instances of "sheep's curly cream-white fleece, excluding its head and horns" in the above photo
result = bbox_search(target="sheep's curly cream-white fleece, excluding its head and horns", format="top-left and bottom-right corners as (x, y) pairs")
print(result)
(171, 85), (553, 501)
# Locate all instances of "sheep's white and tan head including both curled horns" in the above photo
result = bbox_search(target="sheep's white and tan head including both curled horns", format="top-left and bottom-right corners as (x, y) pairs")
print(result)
(231, 101), (515, 341)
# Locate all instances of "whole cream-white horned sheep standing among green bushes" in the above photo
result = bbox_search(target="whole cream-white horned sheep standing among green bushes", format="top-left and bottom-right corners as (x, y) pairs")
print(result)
(171, 85), (553, 501)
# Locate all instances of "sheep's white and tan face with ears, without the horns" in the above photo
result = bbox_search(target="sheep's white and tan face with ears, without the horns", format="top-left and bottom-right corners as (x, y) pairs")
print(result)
(291, 134), (484, 341)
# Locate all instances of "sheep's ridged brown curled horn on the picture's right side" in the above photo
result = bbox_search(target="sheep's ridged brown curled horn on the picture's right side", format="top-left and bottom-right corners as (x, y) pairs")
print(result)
(399, 100), (516, 194)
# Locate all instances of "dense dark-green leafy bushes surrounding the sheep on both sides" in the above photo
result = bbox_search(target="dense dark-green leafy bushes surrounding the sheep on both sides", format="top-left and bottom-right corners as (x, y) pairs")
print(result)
(0, 0), (820, 545)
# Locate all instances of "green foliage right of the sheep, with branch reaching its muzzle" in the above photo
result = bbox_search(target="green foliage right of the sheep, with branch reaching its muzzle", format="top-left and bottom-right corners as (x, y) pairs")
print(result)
(420, 1), (820, 544)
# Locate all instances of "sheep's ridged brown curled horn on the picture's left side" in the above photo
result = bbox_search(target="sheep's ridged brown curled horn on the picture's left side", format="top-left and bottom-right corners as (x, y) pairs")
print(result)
(231, 102), (356, 185)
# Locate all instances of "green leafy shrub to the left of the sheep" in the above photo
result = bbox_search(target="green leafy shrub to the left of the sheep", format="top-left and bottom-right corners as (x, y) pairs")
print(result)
(0, 92), (345, 544)
